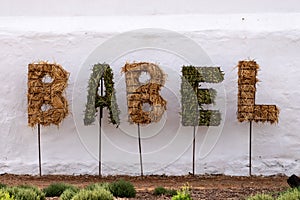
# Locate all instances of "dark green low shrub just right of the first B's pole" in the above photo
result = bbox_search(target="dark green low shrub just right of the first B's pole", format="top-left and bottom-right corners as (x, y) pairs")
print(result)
(43, 183), (78, 197)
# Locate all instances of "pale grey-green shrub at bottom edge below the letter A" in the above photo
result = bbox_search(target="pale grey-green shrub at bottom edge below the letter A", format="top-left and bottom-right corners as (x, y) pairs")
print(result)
(72, 188), (114, 200)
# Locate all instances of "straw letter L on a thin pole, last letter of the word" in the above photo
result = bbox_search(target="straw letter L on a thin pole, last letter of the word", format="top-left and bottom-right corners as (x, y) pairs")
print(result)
(237, 61), (279, 123)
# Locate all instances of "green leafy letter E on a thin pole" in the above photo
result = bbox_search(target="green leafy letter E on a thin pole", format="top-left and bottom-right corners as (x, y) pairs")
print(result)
(181, 66), (224, 126)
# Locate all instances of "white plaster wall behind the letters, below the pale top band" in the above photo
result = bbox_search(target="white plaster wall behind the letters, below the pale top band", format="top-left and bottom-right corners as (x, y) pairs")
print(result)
(0, 10), (300, 175)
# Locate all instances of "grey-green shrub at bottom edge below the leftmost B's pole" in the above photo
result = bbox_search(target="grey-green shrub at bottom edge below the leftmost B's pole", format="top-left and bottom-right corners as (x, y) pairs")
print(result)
(5, 187), (42, 200)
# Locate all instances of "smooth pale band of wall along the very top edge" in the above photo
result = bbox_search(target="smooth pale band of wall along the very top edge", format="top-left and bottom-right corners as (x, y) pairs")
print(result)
(0, 0), (300, 16)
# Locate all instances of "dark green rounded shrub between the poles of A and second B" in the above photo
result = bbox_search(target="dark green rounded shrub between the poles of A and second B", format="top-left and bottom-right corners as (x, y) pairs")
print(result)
(109, 180), (136, 198)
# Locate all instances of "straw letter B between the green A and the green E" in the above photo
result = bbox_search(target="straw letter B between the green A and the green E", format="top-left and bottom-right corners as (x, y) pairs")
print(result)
(122, 62), (167, 124)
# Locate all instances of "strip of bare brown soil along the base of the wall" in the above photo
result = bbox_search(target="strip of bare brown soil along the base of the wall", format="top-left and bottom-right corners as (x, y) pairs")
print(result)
(0, 174), (289, 200)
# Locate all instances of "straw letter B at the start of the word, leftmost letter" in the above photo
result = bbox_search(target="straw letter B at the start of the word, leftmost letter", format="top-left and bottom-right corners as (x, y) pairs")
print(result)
(27, 62), (69, 127)
